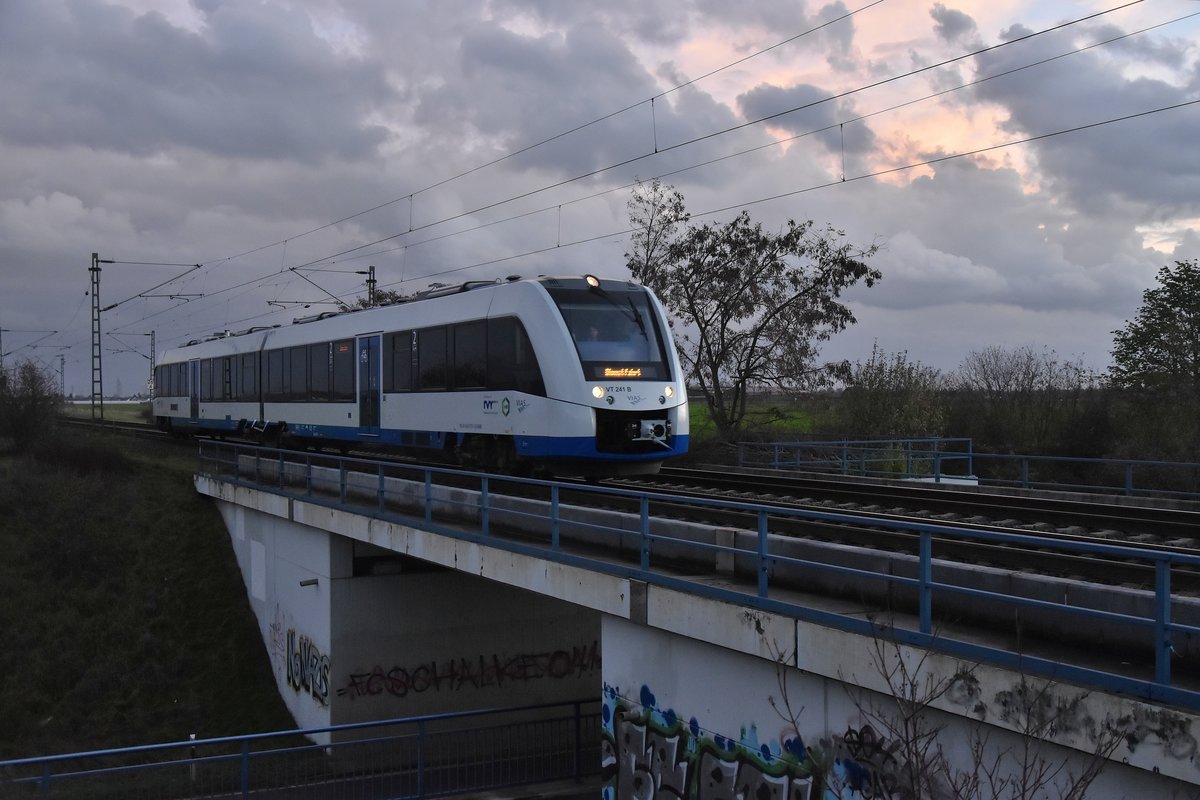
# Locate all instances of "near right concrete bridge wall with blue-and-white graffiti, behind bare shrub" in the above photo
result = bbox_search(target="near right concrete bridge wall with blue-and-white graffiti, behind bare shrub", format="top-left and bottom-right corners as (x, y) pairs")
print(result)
(602, 616), (1200, 800)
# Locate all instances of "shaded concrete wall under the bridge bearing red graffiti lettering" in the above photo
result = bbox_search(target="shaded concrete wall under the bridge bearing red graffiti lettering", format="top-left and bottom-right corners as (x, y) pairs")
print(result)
(332, 571), (600, 723)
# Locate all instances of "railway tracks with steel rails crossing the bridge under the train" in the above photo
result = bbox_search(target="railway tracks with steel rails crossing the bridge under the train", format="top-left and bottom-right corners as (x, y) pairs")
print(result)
(70, 420), (1200, 595)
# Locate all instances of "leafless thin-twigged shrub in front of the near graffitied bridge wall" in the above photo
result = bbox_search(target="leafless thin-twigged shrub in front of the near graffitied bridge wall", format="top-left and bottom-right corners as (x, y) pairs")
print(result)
(768, 626), (1122, 800)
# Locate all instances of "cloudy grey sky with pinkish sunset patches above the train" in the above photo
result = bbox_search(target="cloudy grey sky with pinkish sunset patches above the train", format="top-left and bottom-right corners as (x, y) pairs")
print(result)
(0, 0), (1200, 393)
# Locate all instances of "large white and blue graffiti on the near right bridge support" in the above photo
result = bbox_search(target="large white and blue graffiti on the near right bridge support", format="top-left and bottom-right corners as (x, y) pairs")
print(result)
(602, 686), (817, 800)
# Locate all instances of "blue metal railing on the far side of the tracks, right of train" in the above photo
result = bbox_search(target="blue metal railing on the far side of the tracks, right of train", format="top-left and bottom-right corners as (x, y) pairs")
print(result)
(737, 437), (1200, 500)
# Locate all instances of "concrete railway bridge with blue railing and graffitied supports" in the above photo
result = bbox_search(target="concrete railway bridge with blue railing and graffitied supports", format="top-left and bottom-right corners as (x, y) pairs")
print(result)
(196, 443), (1200, 800)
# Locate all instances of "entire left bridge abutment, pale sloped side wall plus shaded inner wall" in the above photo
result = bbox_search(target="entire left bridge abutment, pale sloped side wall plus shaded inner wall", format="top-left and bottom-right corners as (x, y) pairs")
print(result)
(217, 493), (601, 743)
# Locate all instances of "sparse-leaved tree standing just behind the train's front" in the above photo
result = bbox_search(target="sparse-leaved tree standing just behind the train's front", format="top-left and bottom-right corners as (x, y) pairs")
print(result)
(625, 181), (882, 440)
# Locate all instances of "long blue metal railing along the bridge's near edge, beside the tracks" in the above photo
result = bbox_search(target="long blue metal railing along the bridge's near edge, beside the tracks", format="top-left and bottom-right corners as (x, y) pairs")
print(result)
(200, 443), (1200, 709)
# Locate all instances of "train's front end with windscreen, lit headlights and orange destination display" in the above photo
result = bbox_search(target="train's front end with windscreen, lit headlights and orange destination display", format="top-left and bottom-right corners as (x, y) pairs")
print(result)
(542, 276), (688, 475)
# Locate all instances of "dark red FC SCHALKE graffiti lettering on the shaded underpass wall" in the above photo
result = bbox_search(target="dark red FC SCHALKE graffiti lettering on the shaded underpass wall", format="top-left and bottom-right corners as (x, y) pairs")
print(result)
(337, 640), (600, 699)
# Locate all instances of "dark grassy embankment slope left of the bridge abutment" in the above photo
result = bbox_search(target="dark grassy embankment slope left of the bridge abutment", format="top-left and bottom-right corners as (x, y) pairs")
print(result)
(0, 431), (294, 758)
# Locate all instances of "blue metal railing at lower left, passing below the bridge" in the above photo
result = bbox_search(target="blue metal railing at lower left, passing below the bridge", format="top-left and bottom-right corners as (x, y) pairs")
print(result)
(0, 698), (601, 799)
